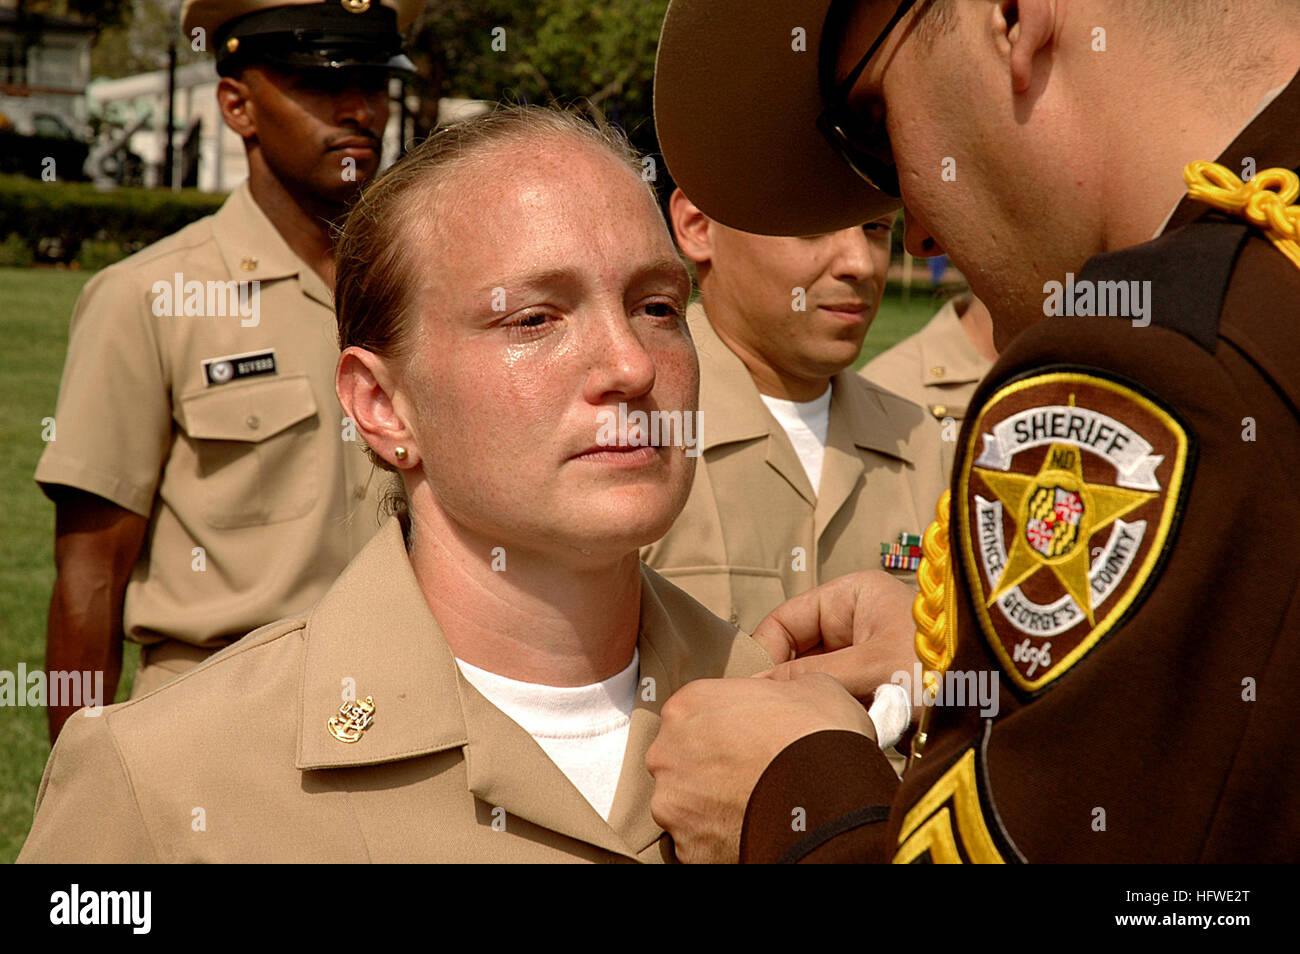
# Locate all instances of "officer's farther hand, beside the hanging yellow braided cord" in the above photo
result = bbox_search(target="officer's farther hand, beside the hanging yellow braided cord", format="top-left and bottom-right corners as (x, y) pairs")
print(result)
(754, 569), (917, 699)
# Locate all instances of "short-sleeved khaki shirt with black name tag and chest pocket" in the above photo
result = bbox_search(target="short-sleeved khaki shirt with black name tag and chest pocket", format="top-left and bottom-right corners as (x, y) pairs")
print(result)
(36, 183), (382, 665)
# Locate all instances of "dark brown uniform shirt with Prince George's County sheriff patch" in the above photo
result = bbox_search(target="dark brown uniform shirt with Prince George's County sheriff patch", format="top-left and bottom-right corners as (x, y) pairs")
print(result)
(741, 67), (1300, 863)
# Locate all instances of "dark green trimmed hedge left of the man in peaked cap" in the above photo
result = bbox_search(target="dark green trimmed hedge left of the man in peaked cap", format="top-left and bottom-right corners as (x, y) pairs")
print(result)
(0, 175), (226, 261)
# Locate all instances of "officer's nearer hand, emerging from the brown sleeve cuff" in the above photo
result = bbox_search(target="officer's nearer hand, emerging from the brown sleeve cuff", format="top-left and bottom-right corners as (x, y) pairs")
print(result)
(646, 675), (875, 863)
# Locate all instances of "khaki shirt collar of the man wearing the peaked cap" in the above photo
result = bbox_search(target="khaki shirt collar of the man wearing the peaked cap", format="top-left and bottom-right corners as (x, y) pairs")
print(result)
(212, 181), (334, 308)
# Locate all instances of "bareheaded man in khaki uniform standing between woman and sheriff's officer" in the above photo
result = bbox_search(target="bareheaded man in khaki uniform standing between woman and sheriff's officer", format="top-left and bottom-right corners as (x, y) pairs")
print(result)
(642, 190), (945, 633)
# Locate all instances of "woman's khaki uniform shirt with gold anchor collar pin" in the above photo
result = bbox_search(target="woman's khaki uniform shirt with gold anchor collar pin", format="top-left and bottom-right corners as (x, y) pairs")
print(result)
(20, 519), (771, 863)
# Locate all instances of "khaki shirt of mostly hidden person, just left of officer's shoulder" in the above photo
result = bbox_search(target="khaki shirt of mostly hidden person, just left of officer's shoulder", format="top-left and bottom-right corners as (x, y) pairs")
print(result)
(861, 300), (993, 478)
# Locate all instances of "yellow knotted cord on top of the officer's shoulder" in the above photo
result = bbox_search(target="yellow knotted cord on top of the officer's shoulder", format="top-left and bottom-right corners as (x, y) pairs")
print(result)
(1183, 160), (1300, 268)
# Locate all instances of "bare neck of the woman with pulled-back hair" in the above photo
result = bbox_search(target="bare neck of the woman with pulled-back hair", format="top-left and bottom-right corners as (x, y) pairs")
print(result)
(411, 485), (641, 686)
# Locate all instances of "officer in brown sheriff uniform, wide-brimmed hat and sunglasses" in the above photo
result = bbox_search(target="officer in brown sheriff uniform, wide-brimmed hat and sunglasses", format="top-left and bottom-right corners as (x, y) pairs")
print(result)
(649, 0), (1300, 862)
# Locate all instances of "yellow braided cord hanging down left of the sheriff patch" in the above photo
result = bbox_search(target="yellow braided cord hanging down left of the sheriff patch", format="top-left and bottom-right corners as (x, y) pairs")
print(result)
(911, 490), (957, 762)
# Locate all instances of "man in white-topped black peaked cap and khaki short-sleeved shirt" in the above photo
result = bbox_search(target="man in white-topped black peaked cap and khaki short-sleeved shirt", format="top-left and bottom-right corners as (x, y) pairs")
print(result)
(36, 0), (419, 738)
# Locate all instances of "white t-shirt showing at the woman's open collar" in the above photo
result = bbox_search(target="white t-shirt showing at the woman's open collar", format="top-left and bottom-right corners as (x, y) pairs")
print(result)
(456, 650), (641, 821)
